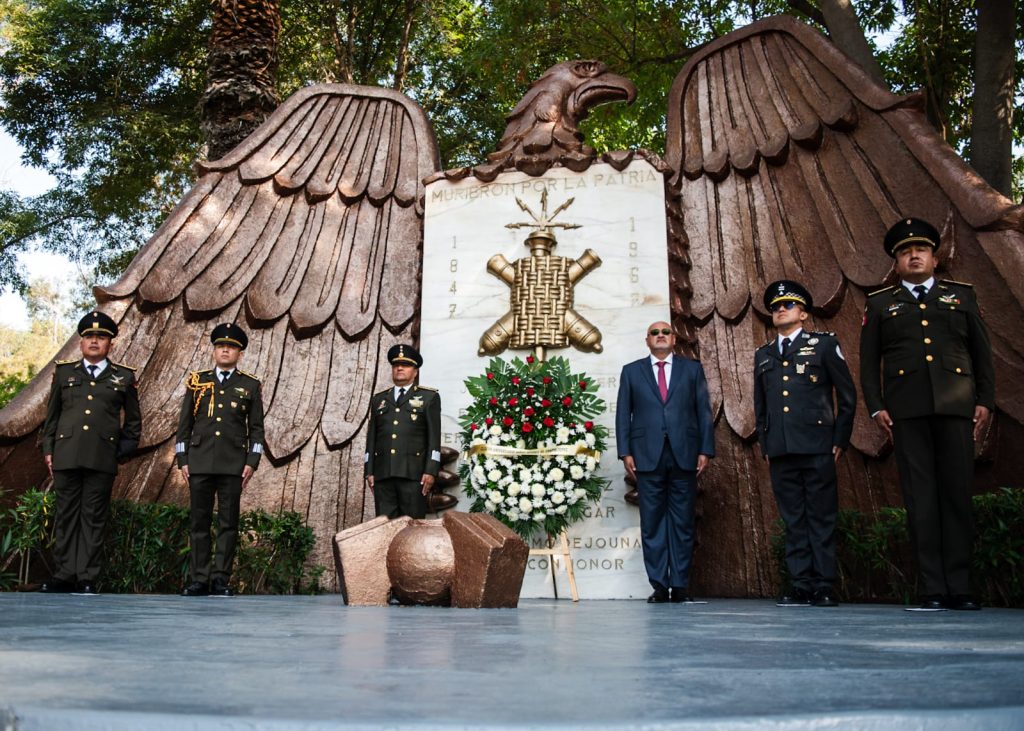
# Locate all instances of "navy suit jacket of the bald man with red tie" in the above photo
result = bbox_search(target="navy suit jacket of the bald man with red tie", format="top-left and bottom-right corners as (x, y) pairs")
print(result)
(615, 355), (715, 472)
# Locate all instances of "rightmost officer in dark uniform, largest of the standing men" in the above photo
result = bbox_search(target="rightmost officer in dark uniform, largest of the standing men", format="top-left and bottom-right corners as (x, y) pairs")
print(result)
(860, 218), (995, 610)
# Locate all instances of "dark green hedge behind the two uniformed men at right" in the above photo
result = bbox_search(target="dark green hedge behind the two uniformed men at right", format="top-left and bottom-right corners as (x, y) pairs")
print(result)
(772, 487), (1024, 607)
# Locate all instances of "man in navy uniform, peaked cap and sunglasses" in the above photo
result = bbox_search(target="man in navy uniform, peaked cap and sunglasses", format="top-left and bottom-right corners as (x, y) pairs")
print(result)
(754, 280), (857, 607)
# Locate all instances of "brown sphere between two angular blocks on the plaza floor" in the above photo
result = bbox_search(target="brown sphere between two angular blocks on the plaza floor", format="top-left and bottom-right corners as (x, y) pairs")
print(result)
(334, 512), (529, 607)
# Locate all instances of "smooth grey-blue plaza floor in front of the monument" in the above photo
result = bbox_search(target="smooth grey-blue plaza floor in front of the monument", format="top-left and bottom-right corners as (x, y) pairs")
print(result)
(0, 594), (1024, 731)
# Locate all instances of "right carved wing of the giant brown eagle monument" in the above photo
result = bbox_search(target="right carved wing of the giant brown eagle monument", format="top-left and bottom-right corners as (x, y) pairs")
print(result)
(666, 17), (1024, 594)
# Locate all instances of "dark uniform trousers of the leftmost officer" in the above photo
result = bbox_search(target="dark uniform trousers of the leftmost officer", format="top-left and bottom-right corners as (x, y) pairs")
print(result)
(53, 469), (117, 582)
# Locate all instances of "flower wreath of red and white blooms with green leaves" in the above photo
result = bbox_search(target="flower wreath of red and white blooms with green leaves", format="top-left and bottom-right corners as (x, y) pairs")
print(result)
(459, 356), (608, 540)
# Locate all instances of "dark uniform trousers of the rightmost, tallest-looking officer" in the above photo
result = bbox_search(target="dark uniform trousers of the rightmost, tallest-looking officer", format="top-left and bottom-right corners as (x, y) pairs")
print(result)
(893, 416), (974, 596)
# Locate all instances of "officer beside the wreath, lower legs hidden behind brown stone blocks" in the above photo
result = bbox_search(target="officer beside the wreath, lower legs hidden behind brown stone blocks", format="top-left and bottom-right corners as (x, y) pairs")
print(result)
(365, 345), (441, 518)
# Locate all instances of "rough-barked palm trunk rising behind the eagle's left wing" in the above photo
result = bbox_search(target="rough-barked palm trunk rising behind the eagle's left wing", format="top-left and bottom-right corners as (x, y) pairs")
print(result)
(200, 0), (281, 160)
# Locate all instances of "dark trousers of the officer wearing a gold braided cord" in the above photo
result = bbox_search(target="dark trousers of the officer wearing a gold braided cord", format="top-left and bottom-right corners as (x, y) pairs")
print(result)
(188, 474), (242, 584)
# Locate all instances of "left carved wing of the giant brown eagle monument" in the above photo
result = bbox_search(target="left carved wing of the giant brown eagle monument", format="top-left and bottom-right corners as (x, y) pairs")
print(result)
(0, 85), (440, 565)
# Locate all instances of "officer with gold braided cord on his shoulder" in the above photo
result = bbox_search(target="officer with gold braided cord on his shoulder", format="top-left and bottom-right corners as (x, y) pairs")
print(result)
(175, 323), (263, 597)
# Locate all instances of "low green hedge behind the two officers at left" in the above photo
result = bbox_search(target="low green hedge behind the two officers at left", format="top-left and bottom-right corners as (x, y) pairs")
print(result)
(0, 489), (325, 594)
